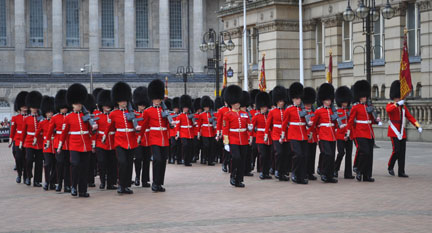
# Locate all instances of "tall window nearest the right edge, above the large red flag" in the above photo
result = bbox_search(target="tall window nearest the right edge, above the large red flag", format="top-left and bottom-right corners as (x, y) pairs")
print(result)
(406, 3), (420, 56)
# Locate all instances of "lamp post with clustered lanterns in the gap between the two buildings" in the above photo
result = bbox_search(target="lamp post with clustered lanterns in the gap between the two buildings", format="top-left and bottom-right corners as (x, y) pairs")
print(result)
(200, 28), (235, 97)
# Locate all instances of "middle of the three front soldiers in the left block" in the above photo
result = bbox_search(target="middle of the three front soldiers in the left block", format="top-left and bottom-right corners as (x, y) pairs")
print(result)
(102, 82), (141, 194)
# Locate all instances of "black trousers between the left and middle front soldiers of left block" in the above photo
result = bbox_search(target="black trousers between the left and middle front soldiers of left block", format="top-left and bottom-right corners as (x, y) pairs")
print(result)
(96, 148), (117, 186)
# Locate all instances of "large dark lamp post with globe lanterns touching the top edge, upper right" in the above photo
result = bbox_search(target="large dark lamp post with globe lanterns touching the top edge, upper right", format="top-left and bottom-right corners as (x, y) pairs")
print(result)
(343, 0), (395, 83)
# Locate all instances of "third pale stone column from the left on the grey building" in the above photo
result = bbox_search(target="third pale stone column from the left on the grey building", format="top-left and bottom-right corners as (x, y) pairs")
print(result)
(89, 0), (100, 73)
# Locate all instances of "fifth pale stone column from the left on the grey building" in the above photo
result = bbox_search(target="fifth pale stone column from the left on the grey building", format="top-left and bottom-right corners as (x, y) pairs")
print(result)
(159, 0), (170, 73)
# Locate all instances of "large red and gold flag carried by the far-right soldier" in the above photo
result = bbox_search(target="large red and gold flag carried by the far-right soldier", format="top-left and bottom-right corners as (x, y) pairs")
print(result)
(399, 31), (413, 99)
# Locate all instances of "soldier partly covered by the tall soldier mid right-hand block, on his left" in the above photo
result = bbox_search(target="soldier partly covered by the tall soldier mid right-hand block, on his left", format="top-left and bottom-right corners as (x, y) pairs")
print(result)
(264, 86), (291, 181)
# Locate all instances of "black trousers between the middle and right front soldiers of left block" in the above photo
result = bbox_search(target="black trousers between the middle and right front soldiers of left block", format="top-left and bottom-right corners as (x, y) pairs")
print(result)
(134, 146), (151, 183)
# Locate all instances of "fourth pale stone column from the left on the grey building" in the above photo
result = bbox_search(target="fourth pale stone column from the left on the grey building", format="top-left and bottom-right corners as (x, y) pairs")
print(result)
(124, 0), (135, 74)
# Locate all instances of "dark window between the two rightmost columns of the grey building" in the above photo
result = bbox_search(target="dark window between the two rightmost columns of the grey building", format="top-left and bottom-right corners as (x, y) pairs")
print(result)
(169, 0), (183, 48)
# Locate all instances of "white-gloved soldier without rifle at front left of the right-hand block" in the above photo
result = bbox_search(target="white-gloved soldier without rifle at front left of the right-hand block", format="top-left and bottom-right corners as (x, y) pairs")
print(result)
(223, 85), (252, 188)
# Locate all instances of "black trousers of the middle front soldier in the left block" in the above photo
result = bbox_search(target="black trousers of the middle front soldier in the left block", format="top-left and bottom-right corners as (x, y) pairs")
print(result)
(116, 146), (135, 188)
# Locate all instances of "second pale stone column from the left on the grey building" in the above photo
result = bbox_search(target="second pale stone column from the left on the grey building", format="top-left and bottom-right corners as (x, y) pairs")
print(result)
(52, 0), (63, 74)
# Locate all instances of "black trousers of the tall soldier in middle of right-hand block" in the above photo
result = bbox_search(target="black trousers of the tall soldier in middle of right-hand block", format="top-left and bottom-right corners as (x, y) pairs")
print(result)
(290, 140), (307, 180)
